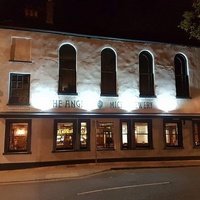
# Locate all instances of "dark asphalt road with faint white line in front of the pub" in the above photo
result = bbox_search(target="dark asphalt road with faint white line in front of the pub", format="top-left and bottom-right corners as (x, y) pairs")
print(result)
(0, 167), (200, 200)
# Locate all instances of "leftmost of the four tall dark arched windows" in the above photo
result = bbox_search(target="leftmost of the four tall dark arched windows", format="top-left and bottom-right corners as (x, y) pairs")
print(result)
(58, 44), (76, 94)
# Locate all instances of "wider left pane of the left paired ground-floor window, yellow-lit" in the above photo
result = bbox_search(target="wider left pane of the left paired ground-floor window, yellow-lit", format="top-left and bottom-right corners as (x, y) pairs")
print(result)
(56, 122), (74, 150)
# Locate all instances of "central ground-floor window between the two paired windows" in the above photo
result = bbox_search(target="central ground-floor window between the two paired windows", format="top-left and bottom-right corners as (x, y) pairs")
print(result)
(96, 121), (114, 150)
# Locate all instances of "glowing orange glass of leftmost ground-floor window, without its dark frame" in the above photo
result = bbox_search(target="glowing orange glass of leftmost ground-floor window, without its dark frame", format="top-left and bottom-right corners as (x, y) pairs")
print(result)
(9, 123), (28, 151)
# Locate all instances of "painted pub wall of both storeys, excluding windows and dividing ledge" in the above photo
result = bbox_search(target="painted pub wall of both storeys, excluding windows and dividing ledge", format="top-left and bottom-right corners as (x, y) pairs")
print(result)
(0, 29), (200, 166)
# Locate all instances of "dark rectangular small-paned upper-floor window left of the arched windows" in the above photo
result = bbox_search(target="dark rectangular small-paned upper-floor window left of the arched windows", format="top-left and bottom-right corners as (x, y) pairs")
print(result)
(8, 73), (30, 105)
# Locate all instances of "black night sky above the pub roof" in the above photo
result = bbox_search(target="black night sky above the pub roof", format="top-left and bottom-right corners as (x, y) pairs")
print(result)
(0, 0), (200, 46)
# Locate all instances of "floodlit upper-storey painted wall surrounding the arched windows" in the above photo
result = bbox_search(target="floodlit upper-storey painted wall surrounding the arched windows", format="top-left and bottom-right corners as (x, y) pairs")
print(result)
(0, 29), (200, 113)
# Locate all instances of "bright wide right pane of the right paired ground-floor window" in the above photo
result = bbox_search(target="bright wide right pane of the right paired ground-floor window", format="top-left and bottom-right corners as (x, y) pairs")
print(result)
(135, 122), (149, 144)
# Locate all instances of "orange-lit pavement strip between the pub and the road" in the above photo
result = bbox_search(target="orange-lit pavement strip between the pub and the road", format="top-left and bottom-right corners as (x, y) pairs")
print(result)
(0, 160), (200, 185)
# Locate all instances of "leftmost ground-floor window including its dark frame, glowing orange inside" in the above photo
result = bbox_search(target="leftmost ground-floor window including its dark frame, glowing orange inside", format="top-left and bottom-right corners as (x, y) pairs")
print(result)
(5, 120), (31, 153)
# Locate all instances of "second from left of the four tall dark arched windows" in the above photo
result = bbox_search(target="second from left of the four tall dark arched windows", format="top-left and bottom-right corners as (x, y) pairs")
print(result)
(101, 48), (116, 96)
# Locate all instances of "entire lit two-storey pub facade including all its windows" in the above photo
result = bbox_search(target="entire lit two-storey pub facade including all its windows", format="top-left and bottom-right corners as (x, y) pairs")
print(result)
(0, 29), (200, 168)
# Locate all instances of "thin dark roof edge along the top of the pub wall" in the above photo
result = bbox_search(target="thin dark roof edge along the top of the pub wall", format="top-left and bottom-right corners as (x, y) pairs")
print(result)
(0, 25), (200, 48)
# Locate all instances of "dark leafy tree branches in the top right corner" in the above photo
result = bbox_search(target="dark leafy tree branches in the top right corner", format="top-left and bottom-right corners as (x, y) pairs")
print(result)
(179, 0), (200, 40)
